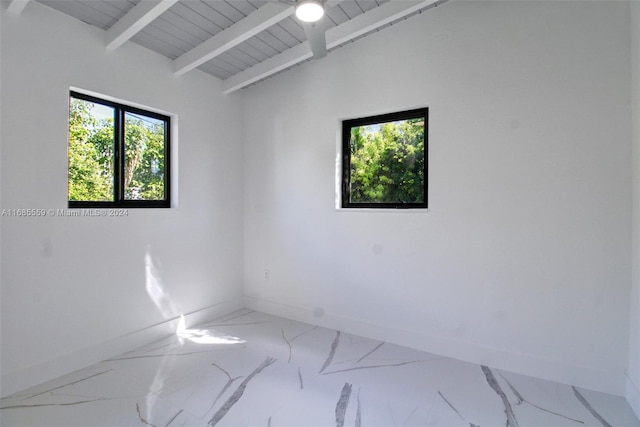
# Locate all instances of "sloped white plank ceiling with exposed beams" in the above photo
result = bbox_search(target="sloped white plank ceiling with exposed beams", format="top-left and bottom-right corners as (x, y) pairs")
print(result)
(8, 0), (446, 93)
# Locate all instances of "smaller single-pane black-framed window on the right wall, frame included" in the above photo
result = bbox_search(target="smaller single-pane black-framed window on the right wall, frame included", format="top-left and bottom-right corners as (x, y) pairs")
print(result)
(342, 108), (428, 209)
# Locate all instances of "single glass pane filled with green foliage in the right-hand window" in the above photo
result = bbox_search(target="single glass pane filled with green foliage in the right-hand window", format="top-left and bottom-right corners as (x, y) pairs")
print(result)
(349, 118), (425, 205)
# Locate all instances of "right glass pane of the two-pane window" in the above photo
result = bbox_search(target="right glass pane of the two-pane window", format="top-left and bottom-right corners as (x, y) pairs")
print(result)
(124, 112), (166, 200)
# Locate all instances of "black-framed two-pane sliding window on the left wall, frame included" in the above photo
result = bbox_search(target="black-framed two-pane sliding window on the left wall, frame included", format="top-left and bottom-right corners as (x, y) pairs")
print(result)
(69, 92), (171, 208)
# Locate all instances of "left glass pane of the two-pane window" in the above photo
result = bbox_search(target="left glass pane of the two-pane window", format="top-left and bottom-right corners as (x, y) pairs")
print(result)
(69, 97), (114, 201)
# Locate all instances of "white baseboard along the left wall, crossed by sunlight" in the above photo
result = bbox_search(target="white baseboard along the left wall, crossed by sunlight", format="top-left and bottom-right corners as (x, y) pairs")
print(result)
(0, 300), (243, 397)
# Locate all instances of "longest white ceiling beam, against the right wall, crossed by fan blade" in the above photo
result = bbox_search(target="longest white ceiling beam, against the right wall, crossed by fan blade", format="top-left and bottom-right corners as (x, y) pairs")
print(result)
(222, 0), (438, 94)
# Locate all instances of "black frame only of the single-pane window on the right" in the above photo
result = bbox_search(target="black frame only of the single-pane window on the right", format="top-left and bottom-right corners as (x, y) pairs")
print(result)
(341, 107), (429, 209)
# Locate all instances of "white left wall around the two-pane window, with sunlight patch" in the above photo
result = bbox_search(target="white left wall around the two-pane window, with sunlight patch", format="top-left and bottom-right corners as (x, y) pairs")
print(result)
(1, 2), (243, 395)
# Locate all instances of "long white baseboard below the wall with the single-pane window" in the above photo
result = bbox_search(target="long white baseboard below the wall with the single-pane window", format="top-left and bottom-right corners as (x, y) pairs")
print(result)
(244, 296), (625, 396)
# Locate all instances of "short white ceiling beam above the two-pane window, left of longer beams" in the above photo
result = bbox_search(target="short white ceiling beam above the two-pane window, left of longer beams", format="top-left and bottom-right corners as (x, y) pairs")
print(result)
(106, 0), (178, 50)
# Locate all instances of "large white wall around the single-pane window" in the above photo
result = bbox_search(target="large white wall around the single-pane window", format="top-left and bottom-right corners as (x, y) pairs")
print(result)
(243, 1), (631, 395)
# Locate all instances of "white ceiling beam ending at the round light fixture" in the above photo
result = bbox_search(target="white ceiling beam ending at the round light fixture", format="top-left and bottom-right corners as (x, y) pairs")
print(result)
(173, 2), (294, 76)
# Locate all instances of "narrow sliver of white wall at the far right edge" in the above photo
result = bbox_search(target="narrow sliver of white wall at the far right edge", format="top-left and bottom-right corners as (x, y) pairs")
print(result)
(627, 2), (640, 417)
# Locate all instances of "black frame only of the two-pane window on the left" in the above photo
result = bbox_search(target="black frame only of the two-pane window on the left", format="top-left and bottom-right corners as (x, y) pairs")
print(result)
(67, 91), (171, 209)
